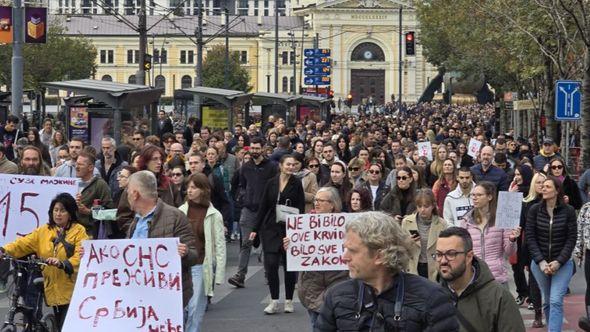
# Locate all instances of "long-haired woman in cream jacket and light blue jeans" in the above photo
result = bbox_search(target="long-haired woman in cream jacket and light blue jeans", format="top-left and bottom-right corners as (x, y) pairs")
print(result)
(179, 173), (226, 332)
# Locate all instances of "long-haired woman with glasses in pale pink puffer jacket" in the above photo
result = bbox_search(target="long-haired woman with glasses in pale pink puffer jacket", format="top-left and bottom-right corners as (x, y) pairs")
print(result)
(461, 181), (520, 286)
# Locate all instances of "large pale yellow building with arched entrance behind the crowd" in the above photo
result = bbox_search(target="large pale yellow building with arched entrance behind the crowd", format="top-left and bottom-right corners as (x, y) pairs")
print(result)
(59, 0), (436, 103)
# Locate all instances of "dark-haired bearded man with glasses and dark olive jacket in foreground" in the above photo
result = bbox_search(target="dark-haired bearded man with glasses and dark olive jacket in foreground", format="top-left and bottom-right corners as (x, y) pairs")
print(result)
(433, 227), (525, 331)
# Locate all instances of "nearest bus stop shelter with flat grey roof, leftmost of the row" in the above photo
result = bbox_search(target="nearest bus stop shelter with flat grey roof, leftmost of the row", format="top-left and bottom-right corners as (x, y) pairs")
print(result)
(43, 79), (164, 143)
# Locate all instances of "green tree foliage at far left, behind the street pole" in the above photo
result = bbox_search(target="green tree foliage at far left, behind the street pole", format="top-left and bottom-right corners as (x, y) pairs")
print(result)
(0, 22), (97, 90)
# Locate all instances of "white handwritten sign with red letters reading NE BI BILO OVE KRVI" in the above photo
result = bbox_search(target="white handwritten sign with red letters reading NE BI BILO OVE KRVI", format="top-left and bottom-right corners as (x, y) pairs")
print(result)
(286, 213), (354, 271)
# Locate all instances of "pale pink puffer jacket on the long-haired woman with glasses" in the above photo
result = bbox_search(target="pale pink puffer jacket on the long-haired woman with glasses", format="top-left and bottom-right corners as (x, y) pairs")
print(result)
(461, 210), (516, 284)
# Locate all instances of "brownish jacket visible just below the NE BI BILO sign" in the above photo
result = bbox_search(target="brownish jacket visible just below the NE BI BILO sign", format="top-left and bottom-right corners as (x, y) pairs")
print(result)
(297, 271), (348, 312)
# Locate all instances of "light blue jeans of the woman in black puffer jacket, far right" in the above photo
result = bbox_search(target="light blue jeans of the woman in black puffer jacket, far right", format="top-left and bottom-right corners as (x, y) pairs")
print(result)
(531, 260), (574, 332)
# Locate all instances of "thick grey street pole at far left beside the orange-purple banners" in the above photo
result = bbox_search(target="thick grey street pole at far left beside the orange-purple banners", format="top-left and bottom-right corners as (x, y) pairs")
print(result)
(10, 0), (25, 122)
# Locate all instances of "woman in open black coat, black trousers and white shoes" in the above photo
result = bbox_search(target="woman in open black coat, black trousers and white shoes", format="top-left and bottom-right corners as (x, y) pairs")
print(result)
(250, 155), (305, 315)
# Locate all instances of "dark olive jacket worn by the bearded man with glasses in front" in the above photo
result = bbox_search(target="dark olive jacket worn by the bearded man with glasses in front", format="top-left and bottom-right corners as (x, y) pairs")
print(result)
(442, 257), (525, 332)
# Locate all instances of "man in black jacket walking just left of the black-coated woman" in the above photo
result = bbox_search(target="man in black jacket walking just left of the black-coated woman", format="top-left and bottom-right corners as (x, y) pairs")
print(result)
(227, 137), (277, 288)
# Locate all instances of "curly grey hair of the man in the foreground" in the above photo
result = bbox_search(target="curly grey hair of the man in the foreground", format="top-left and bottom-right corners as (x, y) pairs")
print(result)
(345, 211), (416, 275)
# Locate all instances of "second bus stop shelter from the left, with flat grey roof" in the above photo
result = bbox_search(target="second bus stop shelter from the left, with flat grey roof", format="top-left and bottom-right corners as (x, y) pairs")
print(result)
(174, 86), (253, 129)
